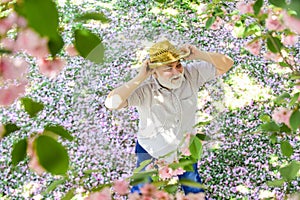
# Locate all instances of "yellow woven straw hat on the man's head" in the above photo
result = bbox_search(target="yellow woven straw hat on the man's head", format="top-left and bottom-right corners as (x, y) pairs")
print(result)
(149, 40), (190, 69)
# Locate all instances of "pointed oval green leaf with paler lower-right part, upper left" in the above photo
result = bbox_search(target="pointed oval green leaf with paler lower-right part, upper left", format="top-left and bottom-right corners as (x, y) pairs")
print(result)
(75, 29), (104, 63)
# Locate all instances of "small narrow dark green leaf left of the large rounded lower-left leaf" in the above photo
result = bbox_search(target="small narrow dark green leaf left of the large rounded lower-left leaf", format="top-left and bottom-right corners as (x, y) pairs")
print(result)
(11, 139), (27, 166)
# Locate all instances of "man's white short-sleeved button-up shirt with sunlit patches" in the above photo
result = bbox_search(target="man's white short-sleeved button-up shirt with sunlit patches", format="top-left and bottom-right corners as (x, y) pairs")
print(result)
(128, 61), (216, 162)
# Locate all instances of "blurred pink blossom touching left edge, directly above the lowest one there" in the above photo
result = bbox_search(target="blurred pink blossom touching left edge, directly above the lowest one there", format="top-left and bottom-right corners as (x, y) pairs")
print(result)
(0, 57), (28, 81)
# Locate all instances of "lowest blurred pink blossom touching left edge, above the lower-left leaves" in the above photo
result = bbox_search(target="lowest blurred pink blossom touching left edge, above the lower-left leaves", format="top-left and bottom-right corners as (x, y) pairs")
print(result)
(0, 82), (27, 106)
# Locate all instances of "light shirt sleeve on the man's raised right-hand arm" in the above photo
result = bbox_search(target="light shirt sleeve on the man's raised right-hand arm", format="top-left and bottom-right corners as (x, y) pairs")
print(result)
(187, 61), (217, 88)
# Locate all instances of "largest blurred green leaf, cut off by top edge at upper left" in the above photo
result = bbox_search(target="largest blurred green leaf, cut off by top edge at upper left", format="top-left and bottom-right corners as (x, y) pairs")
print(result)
(16, 0), (58, 38)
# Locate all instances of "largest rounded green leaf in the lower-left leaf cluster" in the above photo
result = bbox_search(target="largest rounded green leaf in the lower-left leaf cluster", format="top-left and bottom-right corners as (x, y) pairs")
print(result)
(34, 135), (69, 175)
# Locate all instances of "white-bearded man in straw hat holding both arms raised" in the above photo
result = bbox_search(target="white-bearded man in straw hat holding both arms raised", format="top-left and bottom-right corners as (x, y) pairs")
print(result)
(105, 40), (233, 194)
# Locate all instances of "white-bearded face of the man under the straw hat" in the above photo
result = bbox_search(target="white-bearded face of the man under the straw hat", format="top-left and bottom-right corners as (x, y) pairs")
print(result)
(155, 61), (184, 89)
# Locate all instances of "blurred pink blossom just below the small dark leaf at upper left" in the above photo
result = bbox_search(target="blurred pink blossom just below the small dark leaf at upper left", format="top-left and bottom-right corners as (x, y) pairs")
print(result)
(37, 58), (66, 78)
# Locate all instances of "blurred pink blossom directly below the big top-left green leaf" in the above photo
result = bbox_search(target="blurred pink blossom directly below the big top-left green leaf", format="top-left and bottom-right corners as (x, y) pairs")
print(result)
(15, 29), (49, 58)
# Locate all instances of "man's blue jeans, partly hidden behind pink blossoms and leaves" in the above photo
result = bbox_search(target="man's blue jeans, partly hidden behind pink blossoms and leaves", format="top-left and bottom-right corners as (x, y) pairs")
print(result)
(131, 141), (204, 195)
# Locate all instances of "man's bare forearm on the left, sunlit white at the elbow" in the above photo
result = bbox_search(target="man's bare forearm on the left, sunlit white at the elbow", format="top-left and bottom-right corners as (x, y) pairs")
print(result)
(105, 75), (147, 109)
